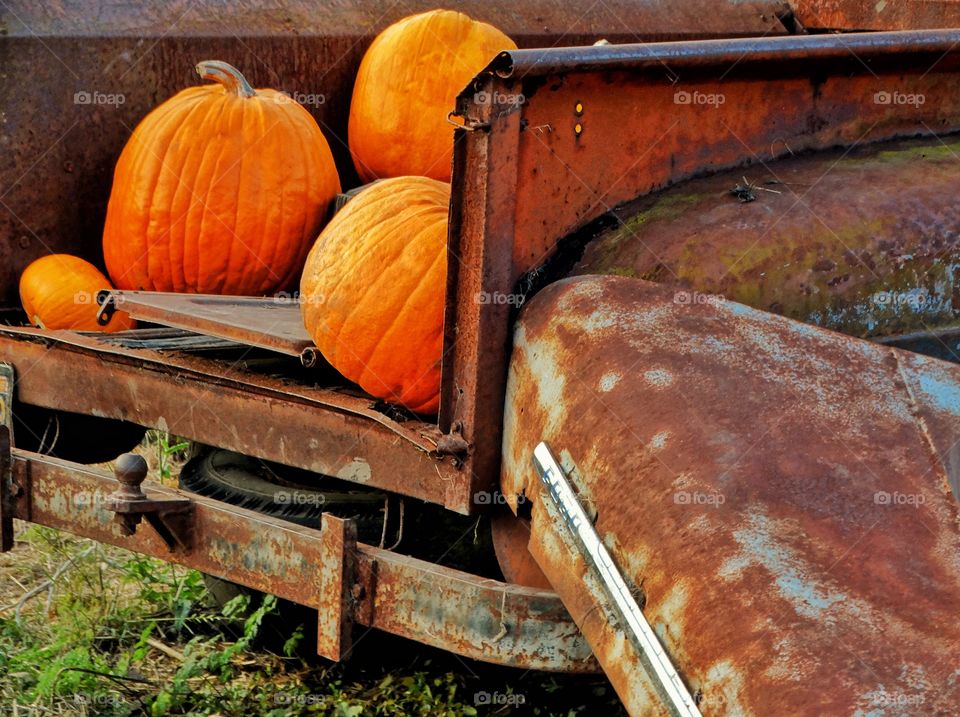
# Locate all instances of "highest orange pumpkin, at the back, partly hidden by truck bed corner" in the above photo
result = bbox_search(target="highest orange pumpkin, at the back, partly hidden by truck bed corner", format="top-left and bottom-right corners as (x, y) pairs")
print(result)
(349, 10), (517, 181)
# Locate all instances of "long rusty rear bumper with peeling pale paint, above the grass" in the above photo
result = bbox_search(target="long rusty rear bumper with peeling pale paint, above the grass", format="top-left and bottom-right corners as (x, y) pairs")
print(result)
(7, 448), (597, 672)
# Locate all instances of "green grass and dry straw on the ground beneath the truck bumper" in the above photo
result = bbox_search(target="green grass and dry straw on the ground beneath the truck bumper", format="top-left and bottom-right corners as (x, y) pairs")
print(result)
(0, 433), (623, 717)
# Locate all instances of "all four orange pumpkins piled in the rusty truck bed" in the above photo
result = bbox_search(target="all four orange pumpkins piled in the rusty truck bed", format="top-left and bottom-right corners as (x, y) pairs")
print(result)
(20, 10), (516, 414)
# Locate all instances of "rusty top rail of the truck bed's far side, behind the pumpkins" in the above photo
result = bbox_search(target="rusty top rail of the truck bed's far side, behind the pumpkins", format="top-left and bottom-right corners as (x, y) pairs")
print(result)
(0, 0), (790, 39)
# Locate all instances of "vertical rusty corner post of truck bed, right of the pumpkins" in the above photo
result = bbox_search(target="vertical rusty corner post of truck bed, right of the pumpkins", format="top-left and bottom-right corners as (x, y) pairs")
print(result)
(439, 88), (521, 504)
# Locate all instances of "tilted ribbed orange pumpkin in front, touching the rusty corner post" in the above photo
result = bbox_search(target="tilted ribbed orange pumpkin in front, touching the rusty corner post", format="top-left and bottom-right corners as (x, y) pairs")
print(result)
(300, 177), (450, 414)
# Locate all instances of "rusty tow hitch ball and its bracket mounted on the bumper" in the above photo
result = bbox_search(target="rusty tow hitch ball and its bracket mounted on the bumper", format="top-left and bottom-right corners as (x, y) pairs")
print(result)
(104, 453), (193, 551)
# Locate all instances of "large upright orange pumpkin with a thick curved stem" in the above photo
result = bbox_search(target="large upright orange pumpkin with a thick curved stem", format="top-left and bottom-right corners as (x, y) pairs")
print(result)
(103, 61), (340, 295)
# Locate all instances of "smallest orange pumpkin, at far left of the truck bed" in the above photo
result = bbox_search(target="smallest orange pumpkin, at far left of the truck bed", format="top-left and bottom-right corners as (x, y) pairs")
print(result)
(20, 254), (136, 332)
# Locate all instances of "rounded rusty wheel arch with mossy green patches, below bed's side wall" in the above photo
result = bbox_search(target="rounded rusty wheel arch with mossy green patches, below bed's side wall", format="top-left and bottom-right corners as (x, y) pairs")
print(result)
(573, 137), (960, 339)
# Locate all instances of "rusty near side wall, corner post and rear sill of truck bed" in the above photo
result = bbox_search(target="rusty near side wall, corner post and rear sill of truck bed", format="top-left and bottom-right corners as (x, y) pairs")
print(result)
(0, 30), (960, 513)
